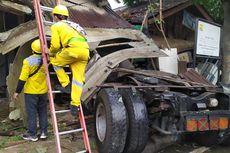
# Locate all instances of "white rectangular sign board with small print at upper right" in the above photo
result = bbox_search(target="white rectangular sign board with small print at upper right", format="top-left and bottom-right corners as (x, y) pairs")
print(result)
(196, 20), (221, 56)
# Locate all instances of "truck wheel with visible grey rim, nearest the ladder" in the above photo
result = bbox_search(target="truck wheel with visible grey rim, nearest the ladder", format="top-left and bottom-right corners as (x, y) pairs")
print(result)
(94, 88), (128, 153)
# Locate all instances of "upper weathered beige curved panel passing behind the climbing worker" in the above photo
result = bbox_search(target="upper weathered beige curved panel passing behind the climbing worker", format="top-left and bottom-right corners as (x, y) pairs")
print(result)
(0, 24), (156, 54)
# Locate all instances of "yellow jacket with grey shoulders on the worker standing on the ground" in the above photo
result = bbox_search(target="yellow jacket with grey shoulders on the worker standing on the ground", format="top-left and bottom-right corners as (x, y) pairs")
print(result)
(19, 54), (47, 94)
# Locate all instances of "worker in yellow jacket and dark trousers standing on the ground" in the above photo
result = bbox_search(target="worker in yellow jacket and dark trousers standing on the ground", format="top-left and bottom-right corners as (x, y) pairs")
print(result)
(13, 39), (48, 141)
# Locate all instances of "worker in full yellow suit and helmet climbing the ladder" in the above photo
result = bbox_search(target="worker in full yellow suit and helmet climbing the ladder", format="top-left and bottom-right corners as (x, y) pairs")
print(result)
(49, 5), (89, 115)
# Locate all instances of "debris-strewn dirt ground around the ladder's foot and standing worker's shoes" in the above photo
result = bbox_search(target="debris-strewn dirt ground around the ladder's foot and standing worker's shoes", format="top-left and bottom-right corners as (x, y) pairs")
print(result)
(0, 102), (97, 153)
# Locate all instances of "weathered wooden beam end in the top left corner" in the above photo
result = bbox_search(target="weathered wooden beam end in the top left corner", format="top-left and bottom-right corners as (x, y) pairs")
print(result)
(0, 0), (32, 15)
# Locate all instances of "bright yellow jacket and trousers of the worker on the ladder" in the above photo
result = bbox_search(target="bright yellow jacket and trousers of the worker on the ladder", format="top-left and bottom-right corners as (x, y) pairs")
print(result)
(49, 20), (89, 106)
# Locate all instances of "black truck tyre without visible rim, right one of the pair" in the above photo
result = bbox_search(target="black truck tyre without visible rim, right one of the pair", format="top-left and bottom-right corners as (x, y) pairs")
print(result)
(121, 89), (148, 153)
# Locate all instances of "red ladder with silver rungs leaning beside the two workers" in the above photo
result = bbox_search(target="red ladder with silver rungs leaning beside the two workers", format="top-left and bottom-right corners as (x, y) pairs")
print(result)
(33, 0), (91, 153)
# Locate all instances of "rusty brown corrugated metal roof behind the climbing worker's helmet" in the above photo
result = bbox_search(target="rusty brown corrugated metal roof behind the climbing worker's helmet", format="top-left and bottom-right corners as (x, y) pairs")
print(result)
(4, 0), (132, 28)
